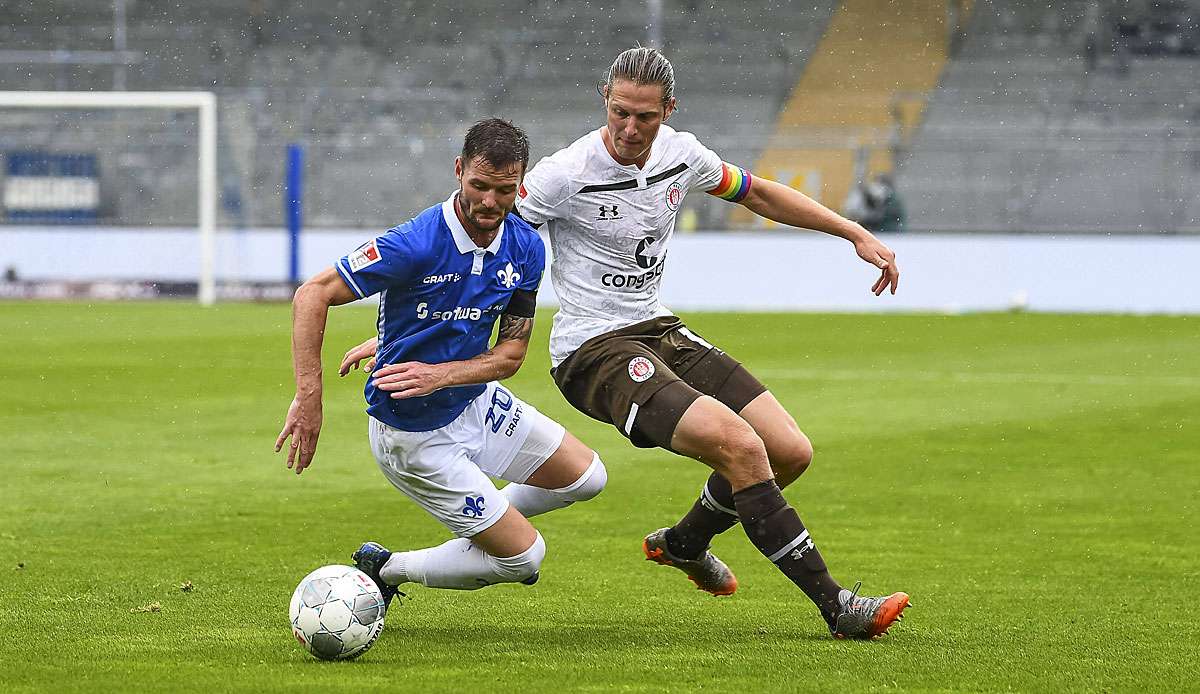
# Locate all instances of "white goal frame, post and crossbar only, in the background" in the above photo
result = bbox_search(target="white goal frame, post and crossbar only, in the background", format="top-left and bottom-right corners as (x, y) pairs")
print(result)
(0, 91), (217, 305)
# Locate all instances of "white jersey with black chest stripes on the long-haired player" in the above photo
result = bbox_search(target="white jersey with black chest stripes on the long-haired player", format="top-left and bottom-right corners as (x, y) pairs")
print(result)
(517, 125), (724, 366)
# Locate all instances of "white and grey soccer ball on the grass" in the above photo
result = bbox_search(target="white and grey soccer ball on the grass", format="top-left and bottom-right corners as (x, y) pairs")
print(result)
(290, 564), (385, 660)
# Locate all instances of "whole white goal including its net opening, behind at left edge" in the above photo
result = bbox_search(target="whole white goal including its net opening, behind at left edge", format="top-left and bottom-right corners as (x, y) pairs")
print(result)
(0, 91), (222, 304)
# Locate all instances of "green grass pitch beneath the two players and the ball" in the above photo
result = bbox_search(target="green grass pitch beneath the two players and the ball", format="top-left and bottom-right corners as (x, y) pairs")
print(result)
(0, 303), (1200, 693)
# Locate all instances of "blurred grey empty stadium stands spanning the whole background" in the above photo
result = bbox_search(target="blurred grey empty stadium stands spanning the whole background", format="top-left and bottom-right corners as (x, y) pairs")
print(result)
(0, 0), (1200, 232)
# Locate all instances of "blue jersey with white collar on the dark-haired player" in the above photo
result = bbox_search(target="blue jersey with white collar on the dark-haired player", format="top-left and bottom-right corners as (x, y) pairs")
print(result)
(337, 193), (546, 431)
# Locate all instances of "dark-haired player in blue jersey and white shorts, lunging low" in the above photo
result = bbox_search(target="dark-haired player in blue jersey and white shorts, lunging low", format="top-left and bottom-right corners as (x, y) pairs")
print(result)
(276, 119), (607, 602)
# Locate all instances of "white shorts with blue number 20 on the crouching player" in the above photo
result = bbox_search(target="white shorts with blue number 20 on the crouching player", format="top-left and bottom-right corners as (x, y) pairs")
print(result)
(370, 381), (566, 538)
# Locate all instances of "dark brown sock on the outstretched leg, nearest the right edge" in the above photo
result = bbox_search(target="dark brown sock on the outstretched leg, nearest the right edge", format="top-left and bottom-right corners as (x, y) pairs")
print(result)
(733, 479), (841, 623)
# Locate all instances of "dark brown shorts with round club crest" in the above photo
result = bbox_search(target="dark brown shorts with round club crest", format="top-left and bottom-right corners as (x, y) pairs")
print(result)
(550, 316), (767, 450)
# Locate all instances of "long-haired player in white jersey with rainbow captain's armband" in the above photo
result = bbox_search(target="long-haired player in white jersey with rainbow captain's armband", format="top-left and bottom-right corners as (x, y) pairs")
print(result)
(517, 48), (908, 638)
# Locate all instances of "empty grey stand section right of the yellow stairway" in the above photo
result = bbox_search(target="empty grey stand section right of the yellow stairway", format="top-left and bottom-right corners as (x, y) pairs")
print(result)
(898, 0), (1200, 232)
